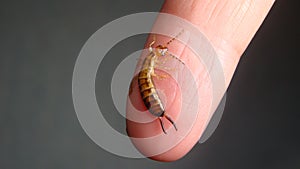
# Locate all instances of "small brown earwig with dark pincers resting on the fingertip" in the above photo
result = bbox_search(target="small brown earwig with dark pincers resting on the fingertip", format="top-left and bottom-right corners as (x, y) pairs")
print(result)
(138, 31), (184, 134)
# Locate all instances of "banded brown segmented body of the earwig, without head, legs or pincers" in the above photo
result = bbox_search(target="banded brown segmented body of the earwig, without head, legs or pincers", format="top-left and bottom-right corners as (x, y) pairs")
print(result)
(138, 56), (165, 117)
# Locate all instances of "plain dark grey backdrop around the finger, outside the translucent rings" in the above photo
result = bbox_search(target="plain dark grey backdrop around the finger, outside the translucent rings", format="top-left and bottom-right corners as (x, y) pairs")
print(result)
(0, 0), (300, 169)
